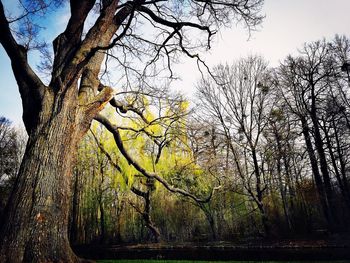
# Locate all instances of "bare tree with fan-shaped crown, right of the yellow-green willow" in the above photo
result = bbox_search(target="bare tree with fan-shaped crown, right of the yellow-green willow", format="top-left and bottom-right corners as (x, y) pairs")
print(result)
(198, 57), (272, 235)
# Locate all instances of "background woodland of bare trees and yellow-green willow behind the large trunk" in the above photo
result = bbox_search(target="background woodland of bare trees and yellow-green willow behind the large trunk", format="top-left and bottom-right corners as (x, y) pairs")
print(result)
(0, 36), (350, 248)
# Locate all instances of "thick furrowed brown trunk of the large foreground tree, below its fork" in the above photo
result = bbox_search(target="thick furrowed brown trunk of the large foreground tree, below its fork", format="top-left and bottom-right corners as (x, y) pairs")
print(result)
(0, 90), (90, 262)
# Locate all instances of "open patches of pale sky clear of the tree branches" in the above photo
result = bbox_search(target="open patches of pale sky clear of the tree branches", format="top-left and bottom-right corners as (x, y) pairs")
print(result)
(0, 0), (350, 124)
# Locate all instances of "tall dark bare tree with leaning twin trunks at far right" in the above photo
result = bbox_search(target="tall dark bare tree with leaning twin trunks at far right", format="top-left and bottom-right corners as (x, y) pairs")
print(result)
(279, 37), (349, 231)
